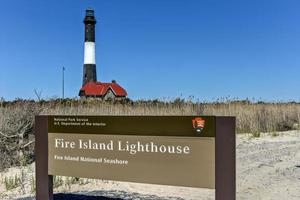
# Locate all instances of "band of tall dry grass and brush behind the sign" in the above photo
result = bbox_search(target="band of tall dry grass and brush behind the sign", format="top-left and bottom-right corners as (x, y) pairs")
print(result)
(0, 99), (300, 170)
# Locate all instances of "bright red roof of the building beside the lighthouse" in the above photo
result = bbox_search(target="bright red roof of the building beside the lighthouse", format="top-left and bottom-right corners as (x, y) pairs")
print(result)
(79, 82), (127, 97)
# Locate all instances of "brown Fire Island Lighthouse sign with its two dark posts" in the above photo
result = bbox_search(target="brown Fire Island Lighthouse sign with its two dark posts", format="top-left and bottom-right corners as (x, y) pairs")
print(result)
(36, 116), (235, 200)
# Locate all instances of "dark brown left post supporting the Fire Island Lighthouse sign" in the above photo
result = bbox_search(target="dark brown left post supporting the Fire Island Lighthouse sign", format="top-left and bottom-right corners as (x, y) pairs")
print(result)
(35, 116), (53, 200)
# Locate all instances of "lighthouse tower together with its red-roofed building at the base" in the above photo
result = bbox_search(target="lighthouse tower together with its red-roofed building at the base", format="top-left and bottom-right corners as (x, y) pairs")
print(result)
(79, 8), (127, 100)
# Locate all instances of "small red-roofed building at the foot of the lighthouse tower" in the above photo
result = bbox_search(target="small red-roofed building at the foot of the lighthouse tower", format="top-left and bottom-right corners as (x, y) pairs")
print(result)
(79, 81), (127, 100)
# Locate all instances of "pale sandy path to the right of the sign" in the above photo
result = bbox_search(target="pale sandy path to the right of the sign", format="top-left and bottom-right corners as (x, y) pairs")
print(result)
(237, 132), (300, 200)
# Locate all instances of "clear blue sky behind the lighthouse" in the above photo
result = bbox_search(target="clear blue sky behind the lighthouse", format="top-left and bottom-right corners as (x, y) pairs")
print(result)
(0, 0), (300, 101)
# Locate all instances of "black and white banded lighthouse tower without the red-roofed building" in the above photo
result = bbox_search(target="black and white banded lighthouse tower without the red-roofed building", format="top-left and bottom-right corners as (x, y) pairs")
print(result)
(82, 8), (97, 86)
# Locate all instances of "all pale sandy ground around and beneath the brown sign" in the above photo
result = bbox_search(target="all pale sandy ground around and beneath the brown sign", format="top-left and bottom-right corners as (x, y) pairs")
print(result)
(0, 131), (300, 200)
